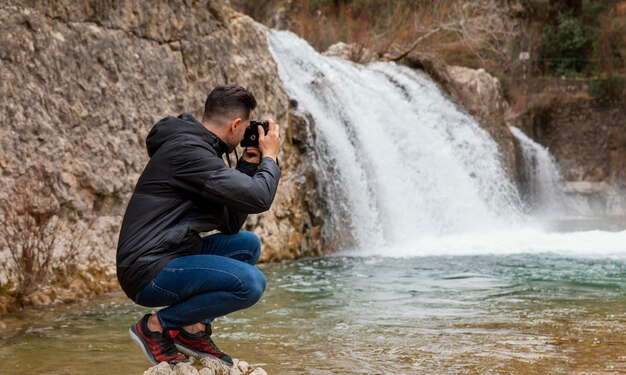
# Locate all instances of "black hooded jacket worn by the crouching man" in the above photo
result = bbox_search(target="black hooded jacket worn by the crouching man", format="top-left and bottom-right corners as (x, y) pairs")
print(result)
(117, 113), (280, 300)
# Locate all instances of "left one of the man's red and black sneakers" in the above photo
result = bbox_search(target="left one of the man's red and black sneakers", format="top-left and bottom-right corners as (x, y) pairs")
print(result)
(129, 314), (188, 365)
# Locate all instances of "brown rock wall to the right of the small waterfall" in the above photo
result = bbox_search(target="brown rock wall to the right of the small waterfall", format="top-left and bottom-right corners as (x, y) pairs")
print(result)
(517, 85), (626, 216)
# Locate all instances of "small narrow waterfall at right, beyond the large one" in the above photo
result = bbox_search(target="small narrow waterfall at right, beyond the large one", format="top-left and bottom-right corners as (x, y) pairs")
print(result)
(509, 126), (566, 217)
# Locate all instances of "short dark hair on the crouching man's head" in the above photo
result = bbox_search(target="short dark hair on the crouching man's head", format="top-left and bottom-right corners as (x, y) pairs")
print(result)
(202, 85), (256, 124)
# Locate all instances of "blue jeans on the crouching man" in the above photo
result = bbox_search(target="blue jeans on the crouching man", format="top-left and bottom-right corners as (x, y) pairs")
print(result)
(137, 231), (265, 329)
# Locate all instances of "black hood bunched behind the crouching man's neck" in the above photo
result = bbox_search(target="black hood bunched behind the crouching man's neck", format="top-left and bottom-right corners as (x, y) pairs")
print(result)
(146, 113), (230, 157)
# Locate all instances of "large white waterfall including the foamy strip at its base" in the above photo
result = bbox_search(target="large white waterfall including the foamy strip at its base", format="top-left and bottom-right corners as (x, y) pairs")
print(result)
(268, 31), (626, 256)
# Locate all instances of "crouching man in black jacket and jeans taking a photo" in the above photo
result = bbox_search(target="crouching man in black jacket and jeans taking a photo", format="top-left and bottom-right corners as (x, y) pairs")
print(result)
(117, 85), (280, 365)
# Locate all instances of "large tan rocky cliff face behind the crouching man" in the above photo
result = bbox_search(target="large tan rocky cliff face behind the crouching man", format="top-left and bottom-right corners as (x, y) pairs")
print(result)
(0, 0), (321, 286)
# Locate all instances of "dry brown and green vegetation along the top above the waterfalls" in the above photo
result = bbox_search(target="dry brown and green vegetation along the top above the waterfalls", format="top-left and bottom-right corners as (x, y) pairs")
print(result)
(233, 0), (626, 98)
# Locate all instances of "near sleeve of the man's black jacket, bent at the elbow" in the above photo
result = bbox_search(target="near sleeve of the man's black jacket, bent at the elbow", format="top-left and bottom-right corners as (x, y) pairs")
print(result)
(172, 143), (280, 214)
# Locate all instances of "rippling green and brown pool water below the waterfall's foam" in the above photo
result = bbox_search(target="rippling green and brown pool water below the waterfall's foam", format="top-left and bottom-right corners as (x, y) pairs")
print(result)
(0, 254), (626, 374)
